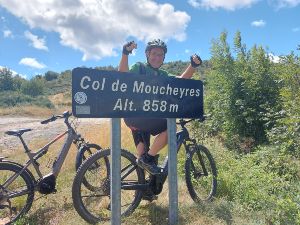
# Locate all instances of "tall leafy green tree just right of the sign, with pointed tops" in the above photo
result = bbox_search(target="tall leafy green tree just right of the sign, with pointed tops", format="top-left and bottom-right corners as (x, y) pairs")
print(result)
(205, 32), (279, 151)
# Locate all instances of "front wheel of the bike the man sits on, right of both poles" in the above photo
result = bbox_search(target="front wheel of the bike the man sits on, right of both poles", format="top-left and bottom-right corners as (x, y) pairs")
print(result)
(185, 145), (217, 202)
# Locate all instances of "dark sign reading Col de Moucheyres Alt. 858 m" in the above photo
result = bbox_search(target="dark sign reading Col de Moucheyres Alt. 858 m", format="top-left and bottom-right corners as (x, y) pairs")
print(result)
(72, 68), (203, 118)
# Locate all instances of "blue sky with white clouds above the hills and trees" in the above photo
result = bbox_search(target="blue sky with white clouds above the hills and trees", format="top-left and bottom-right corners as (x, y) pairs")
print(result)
(0, 0), (300, 79)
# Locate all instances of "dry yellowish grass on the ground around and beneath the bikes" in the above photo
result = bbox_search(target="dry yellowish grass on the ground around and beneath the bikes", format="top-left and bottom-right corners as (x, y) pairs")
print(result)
(0, 114), (268, 225)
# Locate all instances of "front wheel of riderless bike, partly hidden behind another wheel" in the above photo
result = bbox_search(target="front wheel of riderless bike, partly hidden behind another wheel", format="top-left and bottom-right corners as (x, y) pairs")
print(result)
(75, 143), (110, 191)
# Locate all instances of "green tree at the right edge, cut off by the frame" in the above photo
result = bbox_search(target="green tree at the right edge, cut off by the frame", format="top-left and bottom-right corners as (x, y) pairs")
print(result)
(269, 52), (300, 158)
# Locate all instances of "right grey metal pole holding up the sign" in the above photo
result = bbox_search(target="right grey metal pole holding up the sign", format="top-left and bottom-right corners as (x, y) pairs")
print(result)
(167, 119), (178, 225)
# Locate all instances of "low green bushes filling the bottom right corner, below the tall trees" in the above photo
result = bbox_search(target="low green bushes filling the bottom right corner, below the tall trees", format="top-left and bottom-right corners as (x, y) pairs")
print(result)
(217, 144), (300, 224)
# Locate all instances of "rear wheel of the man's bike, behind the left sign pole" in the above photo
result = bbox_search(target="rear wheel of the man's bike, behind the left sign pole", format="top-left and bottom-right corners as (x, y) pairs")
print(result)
(72, 149), (145, 224)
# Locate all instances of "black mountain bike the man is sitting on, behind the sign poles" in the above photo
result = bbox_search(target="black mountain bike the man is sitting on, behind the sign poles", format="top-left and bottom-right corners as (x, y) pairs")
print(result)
(72, 119), (217, 223)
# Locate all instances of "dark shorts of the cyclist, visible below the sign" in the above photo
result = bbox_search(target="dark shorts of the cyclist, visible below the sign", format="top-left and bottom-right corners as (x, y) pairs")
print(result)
(124, 118), (167, 147)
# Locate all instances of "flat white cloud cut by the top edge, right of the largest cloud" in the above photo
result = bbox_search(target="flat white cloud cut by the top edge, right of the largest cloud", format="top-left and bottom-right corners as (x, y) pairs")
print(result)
(188, 0), (259, 11)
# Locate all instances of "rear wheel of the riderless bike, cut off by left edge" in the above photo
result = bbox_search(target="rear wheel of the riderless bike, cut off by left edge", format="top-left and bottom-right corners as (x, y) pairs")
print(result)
(0, 161), (34, 224)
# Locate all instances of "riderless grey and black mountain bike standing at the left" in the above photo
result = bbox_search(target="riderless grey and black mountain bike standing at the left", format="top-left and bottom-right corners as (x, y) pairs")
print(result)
(0, 111), (102, 224)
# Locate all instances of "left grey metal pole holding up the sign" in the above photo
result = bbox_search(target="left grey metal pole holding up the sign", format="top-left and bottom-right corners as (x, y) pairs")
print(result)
(110, 118), (121, 225)
